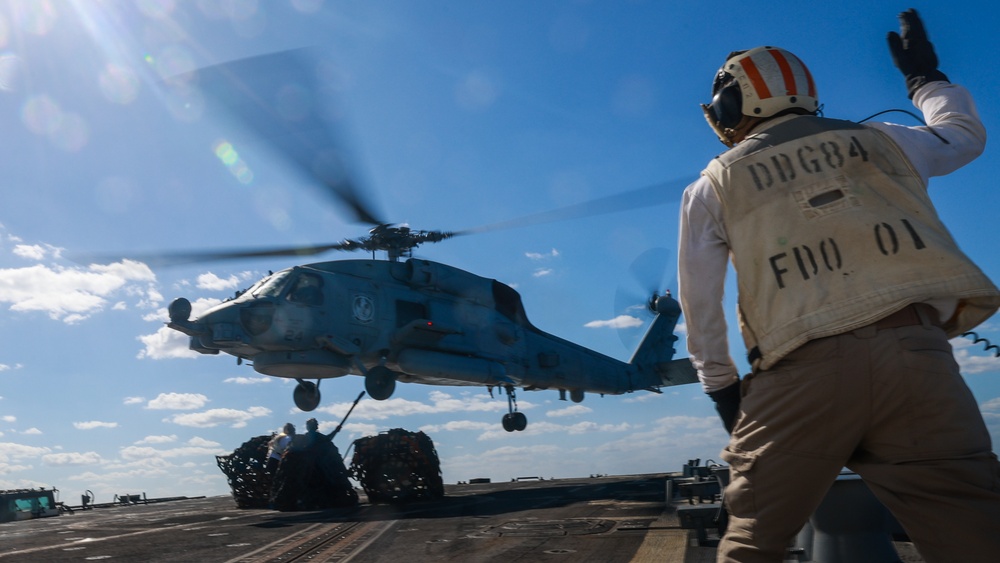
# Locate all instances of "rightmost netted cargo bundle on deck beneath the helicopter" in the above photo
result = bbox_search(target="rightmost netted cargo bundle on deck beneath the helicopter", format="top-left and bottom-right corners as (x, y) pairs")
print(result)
(351, 428), (444, 502)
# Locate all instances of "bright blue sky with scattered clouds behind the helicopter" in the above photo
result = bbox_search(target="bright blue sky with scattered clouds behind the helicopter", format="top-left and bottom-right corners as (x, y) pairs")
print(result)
(0, 0), (1000, 504)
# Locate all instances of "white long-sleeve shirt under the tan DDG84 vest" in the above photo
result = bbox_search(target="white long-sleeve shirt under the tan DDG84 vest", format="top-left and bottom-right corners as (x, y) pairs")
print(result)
(678, 82), (986, 392)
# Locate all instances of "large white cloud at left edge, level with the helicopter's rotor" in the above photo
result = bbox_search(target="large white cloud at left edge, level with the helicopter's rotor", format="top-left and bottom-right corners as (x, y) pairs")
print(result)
(0, 260), (156, 324)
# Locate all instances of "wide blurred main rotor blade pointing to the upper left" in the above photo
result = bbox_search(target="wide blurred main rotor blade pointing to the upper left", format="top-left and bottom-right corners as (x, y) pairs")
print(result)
(176, 49), (385, 225)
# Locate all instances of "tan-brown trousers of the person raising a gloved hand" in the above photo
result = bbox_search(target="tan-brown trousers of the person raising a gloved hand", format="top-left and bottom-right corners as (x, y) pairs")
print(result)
(718, 315), (1000, 563)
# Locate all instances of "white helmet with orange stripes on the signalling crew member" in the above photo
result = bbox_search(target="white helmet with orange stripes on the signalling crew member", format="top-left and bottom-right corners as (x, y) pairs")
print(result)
(701, 47), (819, 147)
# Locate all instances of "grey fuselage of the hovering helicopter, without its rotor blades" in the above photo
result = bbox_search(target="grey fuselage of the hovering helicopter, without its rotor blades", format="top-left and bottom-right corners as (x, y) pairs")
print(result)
(168, 258), (686, 430)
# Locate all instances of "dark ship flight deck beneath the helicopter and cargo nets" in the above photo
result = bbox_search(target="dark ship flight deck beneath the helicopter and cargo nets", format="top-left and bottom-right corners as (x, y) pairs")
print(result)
(0, 474), (922, 563)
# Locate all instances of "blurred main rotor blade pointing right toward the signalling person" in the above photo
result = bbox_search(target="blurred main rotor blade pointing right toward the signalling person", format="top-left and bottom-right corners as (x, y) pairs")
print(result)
(451, 176), (695, 236)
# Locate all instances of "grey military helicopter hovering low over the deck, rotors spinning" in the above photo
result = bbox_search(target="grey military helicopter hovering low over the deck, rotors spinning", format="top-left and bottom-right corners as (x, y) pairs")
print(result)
(101, 51), (697, 432)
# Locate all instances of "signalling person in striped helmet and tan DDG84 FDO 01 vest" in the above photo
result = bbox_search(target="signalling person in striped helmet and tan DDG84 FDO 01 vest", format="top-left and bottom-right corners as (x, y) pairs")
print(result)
(679, 10), (1000, 562)
